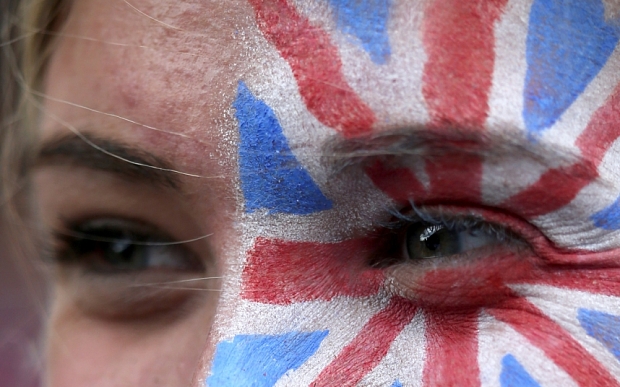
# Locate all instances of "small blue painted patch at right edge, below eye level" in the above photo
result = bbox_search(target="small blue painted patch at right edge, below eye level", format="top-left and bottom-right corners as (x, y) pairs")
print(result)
(577, 309), (620, 360)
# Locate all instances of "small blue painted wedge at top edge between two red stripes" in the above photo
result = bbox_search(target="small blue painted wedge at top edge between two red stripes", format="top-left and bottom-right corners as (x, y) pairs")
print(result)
(328, 0), (392, 64)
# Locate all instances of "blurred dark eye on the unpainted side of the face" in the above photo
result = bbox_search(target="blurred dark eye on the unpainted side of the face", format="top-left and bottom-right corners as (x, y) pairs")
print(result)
(57, 219), (203, 274)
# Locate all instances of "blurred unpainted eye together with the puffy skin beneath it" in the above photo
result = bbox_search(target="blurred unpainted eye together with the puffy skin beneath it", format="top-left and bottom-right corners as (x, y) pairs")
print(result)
(52, 218), (213, 321)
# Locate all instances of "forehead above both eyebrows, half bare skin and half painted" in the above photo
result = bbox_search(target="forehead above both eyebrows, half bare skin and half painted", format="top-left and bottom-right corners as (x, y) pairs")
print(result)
(50, 0), (617, 138)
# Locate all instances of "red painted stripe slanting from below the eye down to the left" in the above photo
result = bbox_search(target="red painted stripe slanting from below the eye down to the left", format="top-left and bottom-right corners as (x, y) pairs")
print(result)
(310, 296), (417, 387)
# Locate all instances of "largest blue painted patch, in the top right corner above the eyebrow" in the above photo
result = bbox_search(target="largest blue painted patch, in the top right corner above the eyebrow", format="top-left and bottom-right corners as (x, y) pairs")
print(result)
(523, 0), (618, 135)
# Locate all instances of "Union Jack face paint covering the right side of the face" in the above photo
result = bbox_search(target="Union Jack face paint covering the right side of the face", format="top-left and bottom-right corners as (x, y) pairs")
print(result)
(205, 0), (620, 387)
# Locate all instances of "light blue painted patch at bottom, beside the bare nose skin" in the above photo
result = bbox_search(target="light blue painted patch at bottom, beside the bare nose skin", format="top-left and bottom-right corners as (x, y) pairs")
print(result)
(205, 331), (328, 387)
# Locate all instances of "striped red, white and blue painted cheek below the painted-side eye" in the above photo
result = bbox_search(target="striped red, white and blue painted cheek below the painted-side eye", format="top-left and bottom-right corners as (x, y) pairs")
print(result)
(201, 230), (620, 386)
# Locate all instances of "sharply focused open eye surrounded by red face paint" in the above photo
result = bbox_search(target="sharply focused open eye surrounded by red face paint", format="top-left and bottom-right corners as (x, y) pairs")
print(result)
(404, 221), (502, 260)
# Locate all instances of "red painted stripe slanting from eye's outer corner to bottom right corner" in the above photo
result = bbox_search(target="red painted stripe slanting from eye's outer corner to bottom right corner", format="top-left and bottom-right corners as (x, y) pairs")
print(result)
(486, 298), (620, 387)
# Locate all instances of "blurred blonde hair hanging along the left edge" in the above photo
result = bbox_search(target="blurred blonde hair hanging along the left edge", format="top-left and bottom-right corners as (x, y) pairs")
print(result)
(0, 0), (70, 255)
